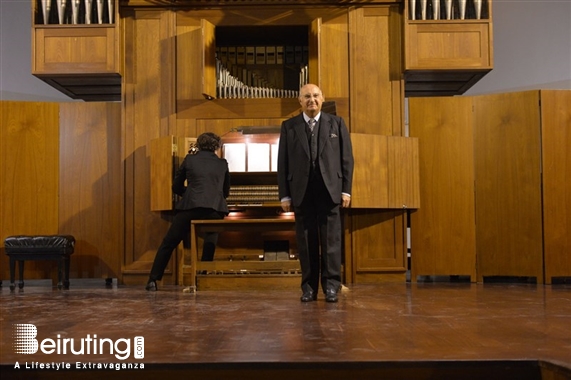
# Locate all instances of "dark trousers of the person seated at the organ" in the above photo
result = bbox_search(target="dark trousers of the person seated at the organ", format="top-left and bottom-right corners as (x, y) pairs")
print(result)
(149, 208), (224, 281)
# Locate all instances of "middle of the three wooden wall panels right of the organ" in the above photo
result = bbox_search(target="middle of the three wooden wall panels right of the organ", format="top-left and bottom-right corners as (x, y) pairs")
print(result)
(474, 91), (543, 283)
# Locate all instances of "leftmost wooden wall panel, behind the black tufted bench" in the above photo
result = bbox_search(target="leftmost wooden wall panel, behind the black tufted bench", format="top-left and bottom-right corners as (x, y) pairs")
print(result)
(0, 101), (59, 279)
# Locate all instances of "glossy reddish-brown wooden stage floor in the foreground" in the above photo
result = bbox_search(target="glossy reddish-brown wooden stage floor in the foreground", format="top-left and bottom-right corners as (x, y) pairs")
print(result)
(0, 280), (571, 380)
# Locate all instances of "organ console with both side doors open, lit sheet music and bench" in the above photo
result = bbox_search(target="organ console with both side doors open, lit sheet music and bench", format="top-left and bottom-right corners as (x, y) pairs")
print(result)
(150, 125), (419, 290)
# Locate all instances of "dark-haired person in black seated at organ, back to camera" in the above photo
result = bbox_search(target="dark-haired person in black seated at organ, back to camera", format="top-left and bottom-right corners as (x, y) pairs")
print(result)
(146, 132), (230, 291)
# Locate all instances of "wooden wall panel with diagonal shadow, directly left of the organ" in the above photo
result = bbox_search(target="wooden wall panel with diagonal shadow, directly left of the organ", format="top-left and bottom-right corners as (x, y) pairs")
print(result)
(59, 102), (124, 278)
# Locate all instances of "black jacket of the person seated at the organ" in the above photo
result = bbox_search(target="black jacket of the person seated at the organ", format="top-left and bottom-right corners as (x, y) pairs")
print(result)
(172, 151), (230, 214)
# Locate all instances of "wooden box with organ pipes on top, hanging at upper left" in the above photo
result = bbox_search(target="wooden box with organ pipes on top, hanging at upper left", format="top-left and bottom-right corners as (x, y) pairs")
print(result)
(32, 0), (122, 101)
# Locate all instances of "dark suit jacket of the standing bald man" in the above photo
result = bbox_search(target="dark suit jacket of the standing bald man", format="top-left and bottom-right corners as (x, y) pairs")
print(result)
(278, 112), (354, 207)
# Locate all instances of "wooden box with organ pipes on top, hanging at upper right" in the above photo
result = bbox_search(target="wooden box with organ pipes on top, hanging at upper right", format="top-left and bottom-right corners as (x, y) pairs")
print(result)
(404, 0), (493, 97)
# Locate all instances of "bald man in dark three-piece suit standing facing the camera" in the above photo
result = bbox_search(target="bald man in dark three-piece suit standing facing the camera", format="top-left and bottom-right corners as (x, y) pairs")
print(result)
(278, 84), (353, 302)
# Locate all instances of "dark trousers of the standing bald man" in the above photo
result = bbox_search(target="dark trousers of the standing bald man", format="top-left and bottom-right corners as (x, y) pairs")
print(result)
(294, 176), (343, 292)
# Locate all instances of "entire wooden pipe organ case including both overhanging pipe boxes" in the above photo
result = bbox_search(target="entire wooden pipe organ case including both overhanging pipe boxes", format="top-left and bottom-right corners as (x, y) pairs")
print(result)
(25, 0), (491, 288)
